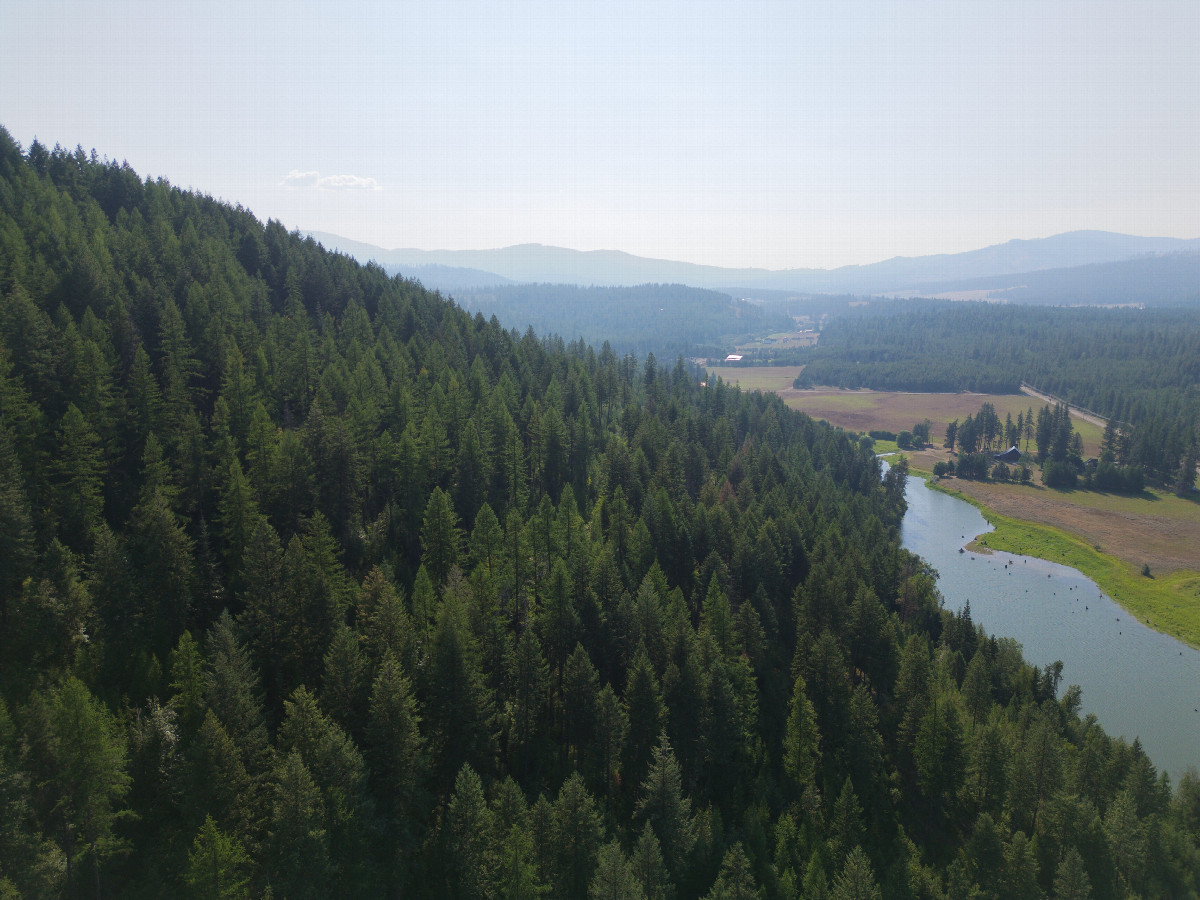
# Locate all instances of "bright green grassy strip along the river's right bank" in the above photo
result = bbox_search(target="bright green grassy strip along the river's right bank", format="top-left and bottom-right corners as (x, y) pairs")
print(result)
(908, 462), (1200, 649)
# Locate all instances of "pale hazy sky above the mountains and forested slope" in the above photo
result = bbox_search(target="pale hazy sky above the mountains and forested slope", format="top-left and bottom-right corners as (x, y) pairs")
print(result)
(0, 0), (1200, 269)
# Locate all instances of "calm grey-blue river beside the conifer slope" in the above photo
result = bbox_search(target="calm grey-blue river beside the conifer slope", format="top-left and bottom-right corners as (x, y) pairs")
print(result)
(901, 475), (1200, 782)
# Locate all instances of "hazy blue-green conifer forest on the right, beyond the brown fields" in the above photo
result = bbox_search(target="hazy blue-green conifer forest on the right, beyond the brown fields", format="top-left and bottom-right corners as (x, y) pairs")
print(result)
(796, 301), (1200, 484)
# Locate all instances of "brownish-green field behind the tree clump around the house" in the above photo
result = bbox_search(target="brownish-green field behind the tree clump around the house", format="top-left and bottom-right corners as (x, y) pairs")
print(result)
(782, 388), (1104, 456)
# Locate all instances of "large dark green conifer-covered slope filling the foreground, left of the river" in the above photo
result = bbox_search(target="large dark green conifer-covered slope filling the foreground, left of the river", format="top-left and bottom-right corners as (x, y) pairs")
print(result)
(0, 131), (1200, 900)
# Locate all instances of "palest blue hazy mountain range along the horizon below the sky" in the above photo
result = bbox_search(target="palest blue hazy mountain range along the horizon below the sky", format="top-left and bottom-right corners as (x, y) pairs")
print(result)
(312, 226), (1200, 294)
